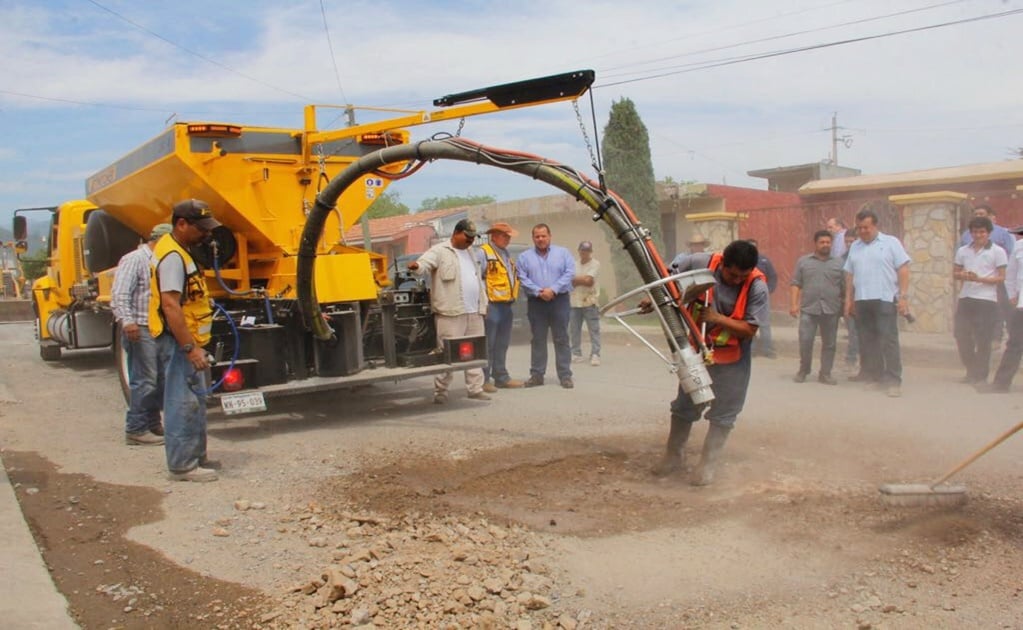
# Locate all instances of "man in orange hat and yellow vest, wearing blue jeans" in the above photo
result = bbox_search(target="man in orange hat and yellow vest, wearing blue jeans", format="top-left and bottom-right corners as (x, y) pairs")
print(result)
(480, 221), (523, 394)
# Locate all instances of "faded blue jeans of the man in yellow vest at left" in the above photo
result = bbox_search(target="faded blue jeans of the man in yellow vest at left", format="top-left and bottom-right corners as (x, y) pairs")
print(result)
(157, 332), (208, 473)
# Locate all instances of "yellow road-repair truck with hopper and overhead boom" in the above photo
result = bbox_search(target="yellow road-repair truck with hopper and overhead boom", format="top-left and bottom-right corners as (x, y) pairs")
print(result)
(14, 71), (593, 412)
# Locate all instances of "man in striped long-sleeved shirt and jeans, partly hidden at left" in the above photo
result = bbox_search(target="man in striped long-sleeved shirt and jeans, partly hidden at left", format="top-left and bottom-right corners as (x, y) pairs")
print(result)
(110, 223), (172, 446)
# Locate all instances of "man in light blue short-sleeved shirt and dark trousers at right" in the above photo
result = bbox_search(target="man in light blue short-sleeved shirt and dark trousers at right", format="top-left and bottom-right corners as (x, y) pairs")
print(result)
(845, 205), (909, 398)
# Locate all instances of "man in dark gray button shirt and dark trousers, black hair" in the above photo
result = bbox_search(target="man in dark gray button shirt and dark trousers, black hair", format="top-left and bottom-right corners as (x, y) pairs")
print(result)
(789, 230), (845, 385)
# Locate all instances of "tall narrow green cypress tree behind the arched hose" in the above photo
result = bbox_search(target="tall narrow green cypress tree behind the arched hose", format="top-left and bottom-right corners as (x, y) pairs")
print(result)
(604, 98), (662, 291)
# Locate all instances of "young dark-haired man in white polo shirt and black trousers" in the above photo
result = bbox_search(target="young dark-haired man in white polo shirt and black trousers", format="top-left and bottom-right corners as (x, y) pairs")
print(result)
(952, 217), (1008, 385)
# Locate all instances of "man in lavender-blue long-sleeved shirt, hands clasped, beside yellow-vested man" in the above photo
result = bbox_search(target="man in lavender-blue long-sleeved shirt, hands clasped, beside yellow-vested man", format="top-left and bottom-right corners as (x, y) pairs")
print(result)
(516, 223), (575, 390)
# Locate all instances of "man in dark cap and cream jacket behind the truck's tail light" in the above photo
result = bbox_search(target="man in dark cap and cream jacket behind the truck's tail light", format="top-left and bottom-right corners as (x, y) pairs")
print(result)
(408, 219), (490, 405)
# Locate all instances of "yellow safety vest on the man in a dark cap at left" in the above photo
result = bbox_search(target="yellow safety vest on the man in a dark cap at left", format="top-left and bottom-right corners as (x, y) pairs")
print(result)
(149, 234), (213, 346)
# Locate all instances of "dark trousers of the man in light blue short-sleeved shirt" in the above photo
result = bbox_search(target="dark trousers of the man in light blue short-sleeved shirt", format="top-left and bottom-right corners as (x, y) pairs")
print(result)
(853, 300), (902, 385)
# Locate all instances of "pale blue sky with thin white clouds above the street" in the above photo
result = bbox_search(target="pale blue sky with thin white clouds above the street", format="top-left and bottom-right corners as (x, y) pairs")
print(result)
(0, 0), (1023, 225)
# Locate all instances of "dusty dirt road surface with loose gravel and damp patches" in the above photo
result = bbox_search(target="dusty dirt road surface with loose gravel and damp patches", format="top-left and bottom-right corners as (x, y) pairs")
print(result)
(0, 324), (1023, 629)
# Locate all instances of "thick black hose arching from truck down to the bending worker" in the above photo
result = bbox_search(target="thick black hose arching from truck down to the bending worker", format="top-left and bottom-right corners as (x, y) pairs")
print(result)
(297, 137), (699, 348)
